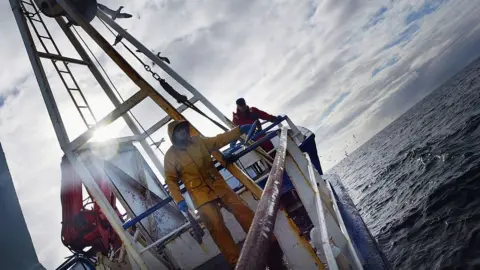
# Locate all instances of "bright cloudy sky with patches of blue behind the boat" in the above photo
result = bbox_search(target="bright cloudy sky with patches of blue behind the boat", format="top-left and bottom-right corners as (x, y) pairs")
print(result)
(0, 0), (480, 269)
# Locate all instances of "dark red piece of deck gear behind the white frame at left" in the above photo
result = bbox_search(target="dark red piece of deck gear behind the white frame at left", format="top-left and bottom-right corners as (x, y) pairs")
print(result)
(60, 157), (122, 256)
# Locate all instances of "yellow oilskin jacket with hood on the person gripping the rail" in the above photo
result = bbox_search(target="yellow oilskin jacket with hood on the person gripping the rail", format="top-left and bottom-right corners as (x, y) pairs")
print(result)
(164, 121), (241, 209)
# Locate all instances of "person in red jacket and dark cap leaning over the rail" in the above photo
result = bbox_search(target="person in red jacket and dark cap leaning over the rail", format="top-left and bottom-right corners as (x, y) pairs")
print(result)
(232, 98), (278, 153)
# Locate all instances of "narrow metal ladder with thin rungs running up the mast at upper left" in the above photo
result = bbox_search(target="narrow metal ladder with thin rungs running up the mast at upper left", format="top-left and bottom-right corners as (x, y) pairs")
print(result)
(20, 0), (97, 128)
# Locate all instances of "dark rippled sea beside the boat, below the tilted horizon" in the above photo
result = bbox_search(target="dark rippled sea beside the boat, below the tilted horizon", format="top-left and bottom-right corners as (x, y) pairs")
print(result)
(330, 60), (480, 269)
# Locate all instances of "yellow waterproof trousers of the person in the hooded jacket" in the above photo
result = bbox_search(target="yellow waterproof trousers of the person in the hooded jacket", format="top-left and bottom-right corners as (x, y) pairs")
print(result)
(198, 189), (254, 265)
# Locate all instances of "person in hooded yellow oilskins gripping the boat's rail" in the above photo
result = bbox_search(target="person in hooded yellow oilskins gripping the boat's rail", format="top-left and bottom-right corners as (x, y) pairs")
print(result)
(164, 121), (283, 269)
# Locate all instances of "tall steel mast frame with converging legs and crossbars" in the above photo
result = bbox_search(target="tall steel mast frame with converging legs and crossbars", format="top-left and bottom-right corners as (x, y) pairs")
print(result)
(10, 0), (261, 269)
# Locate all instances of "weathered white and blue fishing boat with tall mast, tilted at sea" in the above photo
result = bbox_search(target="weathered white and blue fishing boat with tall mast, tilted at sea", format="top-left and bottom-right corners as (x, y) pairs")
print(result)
(4, 0), (389, 270)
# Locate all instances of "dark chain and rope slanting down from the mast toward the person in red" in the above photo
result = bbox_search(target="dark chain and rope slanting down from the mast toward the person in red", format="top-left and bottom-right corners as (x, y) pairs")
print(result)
(100, 17), (229, 131)
